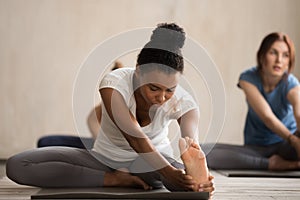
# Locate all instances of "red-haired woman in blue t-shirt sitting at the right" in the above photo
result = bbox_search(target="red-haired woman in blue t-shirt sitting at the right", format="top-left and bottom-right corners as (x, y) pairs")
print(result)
(202, 33), (300, 170)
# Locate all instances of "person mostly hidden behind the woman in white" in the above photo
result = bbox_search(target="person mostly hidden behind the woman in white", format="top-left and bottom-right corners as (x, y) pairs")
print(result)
(37, 61), (123, 149)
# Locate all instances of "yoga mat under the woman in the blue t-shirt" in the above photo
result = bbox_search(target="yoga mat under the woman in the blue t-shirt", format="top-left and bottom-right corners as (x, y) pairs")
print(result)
(217, 170), (300, 178)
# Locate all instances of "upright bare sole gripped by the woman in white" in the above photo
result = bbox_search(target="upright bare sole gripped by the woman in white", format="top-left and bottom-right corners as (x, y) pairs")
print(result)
(179, 137), (209, 191)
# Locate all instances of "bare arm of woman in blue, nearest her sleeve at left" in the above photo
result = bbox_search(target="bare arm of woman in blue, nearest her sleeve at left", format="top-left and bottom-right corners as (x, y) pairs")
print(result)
(239, 80), (291, 140)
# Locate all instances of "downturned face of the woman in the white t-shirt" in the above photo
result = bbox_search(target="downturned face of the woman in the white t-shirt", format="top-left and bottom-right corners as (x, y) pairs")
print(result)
(139, 70), (180, 106)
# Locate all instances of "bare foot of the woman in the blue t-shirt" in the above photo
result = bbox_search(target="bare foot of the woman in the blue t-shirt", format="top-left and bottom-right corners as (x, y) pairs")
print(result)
(268, 155), (300, 171)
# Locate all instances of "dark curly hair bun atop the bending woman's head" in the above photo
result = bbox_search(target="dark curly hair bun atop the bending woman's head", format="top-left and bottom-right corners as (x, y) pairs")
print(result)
(148, 23), (185, 51)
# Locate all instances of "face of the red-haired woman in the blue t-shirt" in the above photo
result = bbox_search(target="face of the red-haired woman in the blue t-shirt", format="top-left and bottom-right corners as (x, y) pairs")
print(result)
(262, 41), (290, 77)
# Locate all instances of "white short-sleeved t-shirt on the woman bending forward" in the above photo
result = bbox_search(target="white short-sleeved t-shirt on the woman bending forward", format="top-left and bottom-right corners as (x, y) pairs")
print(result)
(93, 68), (198, 162)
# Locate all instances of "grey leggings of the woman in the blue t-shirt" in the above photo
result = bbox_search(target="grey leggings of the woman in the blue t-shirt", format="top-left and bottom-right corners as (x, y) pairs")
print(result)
(201, 139), (298, 169)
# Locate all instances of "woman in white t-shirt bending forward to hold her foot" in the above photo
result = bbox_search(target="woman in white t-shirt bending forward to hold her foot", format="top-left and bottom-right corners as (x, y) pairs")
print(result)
(6, 23), (214, 193)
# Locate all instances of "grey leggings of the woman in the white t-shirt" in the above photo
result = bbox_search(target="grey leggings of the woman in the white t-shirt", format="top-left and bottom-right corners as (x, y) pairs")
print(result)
(6, 147), (184, 191)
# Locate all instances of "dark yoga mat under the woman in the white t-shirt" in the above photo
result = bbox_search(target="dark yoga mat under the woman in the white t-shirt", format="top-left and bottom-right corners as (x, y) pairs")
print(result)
(31, 187), (209, 200)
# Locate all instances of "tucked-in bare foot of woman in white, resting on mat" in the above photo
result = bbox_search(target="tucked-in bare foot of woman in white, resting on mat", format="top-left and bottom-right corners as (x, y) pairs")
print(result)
(103, 169), (152, 190)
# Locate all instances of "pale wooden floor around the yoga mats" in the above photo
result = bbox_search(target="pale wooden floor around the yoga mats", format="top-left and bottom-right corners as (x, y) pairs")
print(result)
(0, 161), (300, 200)
